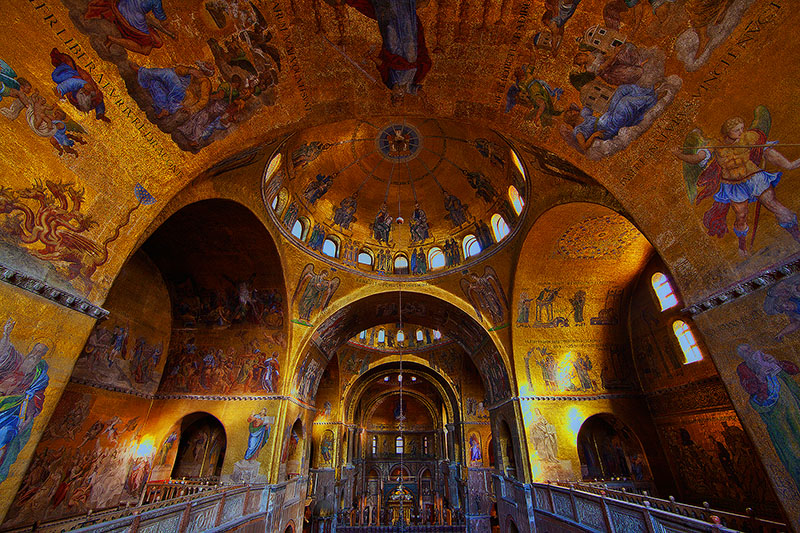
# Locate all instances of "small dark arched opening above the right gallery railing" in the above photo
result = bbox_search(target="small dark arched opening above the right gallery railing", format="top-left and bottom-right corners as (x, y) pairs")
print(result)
(578, 413), (652, 481)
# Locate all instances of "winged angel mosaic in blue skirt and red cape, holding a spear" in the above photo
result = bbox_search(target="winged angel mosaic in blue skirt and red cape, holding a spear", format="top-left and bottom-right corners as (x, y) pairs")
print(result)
(672, 106), (800, 256)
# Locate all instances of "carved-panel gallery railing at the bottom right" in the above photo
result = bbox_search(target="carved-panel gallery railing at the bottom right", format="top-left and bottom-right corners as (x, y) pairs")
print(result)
(532, 482), (788, 533)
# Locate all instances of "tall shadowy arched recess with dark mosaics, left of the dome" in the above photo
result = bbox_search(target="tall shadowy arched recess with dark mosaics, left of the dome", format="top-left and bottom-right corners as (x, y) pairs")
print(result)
(141, 199), (287, 396)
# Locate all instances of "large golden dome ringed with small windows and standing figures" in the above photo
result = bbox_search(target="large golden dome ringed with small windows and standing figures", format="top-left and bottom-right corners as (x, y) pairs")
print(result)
(264, 117), (527, 277)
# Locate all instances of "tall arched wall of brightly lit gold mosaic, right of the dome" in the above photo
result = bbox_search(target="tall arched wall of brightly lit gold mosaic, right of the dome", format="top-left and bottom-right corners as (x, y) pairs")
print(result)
(511, 202), (653, 396)
